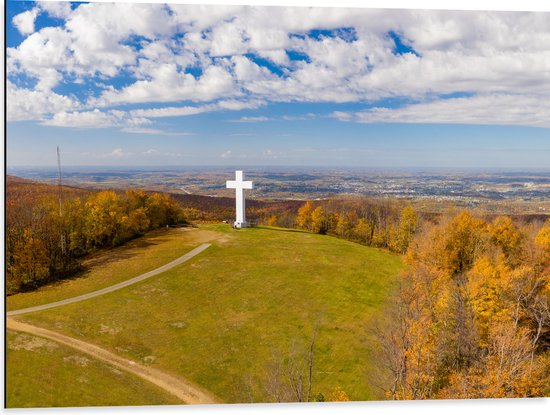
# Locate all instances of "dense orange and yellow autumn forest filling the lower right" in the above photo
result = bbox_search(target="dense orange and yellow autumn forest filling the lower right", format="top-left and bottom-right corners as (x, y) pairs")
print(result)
(379, 212), (550, 399)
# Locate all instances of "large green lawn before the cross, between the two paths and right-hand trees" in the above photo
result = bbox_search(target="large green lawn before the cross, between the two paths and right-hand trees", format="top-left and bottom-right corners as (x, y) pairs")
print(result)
(8, 225), (402, 402)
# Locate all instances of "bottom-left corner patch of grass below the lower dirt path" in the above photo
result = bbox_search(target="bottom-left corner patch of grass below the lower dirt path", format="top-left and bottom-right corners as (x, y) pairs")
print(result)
(6, 331), (181, 408)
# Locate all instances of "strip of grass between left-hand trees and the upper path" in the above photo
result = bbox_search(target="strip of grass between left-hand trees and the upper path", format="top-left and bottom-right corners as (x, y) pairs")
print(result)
(6, 228), (222, 311)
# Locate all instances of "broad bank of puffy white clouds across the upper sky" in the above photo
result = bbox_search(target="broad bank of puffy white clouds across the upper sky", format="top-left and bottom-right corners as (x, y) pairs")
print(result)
(7, 2), (550, 129)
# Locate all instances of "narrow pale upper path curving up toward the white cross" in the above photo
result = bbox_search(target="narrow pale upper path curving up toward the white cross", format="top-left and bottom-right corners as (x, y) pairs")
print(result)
(6, 243), (210, 317)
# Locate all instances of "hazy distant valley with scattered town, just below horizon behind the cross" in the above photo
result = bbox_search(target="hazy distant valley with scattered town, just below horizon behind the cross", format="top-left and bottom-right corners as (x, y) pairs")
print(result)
(8, 166), (550, 214)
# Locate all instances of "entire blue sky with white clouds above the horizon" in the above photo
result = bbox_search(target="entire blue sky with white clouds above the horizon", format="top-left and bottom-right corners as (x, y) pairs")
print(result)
(6, 1), (550, 169)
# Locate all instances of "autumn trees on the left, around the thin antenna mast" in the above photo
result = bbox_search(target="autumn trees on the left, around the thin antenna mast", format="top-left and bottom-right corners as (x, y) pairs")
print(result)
(6, 190), (184, 295)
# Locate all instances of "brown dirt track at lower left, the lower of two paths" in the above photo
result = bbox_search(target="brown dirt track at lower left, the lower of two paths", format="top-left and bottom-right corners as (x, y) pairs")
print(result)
(6, 318), (219, 404)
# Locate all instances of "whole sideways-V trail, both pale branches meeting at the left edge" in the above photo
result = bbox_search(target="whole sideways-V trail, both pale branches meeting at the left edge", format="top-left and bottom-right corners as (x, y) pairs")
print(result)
(6, 243), (219, 404)
